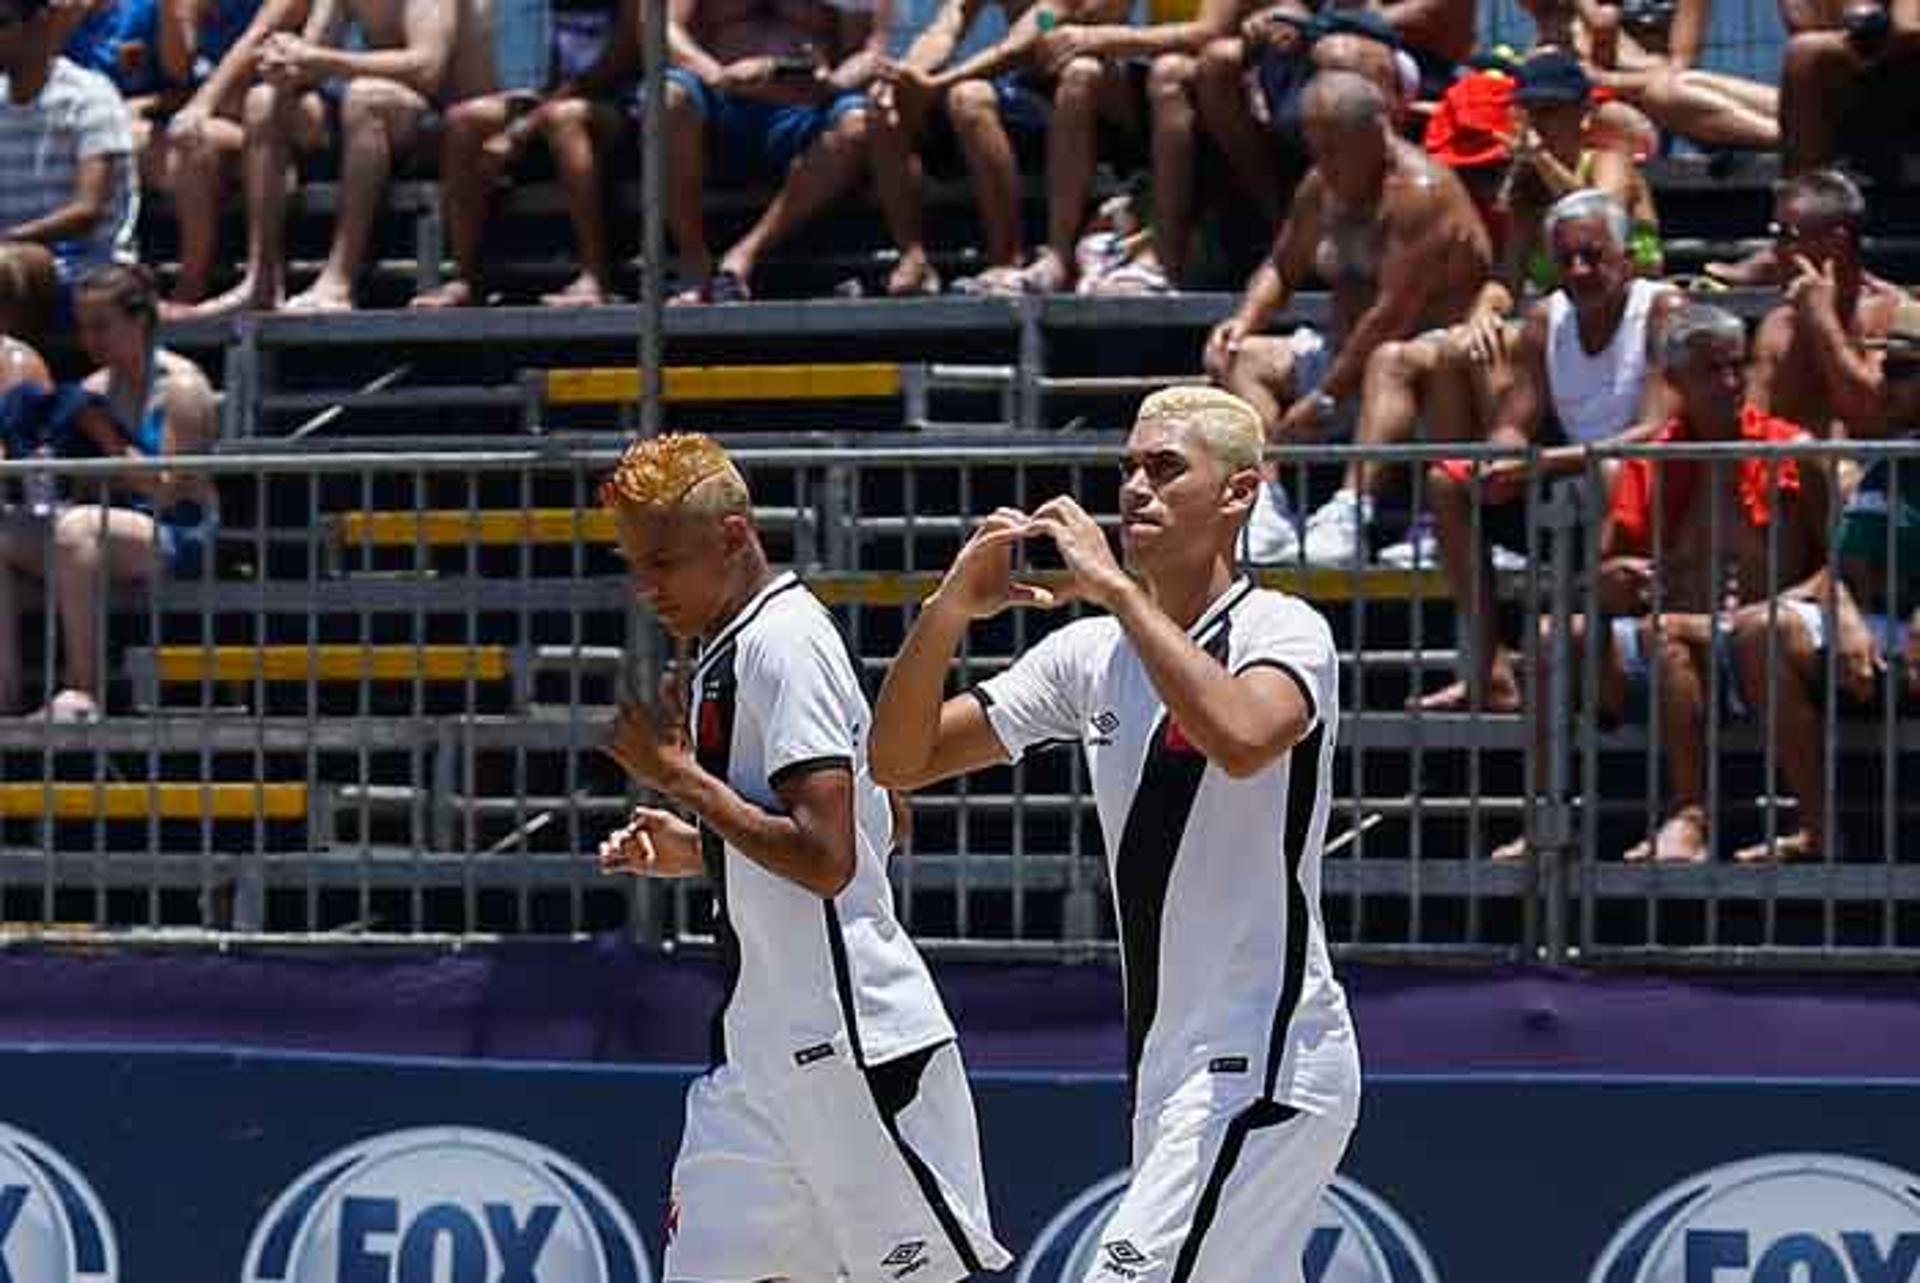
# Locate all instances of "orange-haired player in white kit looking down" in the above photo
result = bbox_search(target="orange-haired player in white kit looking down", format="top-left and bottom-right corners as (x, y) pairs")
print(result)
(599, 434), (1010, 1283)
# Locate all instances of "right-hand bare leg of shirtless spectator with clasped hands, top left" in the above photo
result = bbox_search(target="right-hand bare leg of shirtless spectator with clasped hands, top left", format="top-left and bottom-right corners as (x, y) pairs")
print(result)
(286, 77), (430, 311)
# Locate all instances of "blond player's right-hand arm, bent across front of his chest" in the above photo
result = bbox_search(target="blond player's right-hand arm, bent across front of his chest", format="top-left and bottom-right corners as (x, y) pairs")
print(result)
(1033, 496), (1313, 778)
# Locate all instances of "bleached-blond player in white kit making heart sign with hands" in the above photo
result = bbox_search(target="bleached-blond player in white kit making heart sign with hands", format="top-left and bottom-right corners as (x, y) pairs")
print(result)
(872, 388), (1359, 1283)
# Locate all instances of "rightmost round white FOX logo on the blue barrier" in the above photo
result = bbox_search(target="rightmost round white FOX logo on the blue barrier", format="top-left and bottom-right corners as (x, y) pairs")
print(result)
(1590, 1154), (1920, 1283)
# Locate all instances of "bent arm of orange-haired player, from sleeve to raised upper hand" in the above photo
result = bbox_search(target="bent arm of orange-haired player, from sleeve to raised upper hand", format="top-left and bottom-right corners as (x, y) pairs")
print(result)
(607, 705), (854, 899)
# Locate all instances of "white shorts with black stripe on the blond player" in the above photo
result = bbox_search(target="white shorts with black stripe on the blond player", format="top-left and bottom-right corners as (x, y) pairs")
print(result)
(1085, 1093), (1354, 1283)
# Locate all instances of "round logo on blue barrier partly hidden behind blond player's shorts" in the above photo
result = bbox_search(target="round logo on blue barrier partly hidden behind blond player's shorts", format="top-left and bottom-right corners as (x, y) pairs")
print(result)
(1016, 1172), (1443, 1283)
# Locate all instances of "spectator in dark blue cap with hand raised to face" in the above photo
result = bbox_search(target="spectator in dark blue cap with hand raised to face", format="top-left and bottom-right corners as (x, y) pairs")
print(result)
(1498, 50), (1663, 294)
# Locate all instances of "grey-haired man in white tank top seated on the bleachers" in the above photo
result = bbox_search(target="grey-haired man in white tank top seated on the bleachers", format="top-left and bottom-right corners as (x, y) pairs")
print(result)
(1419, 188), (1684, 713)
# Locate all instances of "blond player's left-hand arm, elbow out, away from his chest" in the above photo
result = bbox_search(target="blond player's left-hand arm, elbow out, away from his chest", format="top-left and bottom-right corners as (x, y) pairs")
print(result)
(868, 507), (1052, 789)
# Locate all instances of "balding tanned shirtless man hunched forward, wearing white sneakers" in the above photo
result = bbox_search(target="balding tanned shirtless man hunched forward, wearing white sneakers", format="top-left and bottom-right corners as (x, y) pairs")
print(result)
(1204, 71), (1505, 561)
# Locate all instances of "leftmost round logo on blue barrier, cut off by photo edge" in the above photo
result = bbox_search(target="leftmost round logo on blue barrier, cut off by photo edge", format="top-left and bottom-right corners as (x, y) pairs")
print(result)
(0, 1124), (119, 1283)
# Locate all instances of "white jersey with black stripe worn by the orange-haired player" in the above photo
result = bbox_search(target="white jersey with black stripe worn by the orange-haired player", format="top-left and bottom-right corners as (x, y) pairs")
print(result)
(687, 574), (954, 1072)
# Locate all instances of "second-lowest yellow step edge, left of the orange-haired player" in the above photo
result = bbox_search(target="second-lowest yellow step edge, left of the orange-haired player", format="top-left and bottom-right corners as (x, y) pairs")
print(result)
(154, 642), (507, 682)
